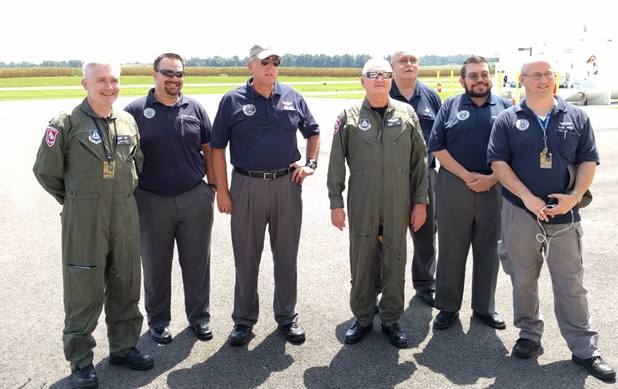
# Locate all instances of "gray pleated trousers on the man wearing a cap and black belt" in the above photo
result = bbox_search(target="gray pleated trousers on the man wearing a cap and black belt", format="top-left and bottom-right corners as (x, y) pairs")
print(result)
(230, 171), (303, 327)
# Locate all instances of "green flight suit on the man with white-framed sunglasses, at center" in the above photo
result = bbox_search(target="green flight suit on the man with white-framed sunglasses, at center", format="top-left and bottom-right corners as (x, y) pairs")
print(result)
(327, 99), (429, 326)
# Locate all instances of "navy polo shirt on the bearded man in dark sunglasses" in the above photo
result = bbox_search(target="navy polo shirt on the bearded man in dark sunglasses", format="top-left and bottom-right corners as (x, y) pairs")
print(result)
(124, 88), (212, 197)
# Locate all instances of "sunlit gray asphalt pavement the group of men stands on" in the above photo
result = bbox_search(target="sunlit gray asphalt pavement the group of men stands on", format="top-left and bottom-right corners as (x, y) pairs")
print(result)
(0, 96), (618, 389)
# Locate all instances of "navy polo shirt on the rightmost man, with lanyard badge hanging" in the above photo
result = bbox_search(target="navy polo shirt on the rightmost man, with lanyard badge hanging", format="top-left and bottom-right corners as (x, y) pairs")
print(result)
(487, 96), (600, 224)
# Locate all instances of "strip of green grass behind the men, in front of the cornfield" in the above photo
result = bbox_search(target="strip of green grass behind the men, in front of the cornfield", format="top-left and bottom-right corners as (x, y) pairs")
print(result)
(0, 76), (463, 101)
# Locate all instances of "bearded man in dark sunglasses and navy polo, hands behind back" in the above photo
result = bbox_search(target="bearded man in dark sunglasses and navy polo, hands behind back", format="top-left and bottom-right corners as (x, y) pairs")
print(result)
(125, 53), (217, 343)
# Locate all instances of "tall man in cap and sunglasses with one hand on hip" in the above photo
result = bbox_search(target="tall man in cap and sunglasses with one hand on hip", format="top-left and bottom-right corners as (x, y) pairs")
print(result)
(211, 45), (320, 346)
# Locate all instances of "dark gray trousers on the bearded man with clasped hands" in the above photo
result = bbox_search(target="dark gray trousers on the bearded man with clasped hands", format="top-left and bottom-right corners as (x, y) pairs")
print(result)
(435, 167), (502, 315)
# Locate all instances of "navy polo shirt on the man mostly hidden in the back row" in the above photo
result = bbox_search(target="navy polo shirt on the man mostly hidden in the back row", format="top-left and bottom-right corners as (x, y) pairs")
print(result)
(390, 81), (442, 167)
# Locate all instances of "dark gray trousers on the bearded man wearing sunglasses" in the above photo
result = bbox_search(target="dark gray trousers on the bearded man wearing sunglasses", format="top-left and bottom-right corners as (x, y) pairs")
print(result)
(135, 181), (215, 328)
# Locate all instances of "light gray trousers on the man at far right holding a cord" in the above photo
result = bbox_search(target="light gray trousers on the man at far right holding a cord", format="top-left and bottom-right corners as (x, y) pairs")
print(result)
(500, 201), (601, 358)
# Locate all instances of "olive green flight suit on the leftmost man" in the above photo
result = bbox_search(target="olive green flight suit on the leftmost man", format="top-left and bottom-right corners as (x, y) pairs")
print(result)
(33, 99), (143, 369)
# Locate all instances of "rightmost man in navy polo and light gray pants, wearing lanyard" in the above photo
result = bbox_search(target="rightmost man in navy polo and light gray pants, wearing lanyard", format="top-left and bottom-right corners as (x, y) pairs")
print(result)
(487, 57), (616, 380)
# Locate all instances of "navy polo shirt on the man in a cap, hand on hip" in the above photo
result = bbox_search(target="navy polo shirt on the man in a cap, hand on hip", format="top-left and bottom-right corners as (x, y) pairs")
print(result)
(210, 78), (320, 171)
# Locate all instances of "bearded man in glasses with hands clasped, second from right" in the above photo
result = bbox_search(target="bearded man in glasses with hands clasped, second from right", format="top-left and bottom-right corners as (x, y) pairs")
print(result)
(428, 56), (511, 329)
